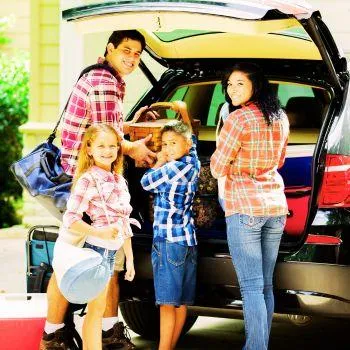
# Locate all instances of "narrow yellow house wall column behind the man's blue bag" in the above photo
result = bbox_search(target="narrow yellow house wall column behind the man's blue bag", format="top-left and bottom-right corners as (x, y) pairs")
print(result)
(21, 0), (60, 225)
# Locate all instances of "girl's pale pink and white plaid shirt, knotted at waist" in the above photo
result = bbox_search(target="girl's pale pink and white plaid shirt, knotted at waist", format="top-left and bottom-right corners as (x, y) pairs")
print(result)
(63, 166), (138, 237)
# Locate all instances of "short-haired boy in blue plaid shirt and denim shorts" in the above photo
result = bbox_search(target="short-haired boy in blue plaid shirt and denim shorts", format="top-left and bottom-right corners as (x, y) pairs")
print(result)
(141, 121), (200, 350)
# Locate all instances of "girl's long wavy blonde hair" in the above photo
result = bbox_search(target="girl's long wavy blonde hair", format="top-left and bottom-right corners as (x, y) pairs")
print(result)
(73, 124), (123, 187)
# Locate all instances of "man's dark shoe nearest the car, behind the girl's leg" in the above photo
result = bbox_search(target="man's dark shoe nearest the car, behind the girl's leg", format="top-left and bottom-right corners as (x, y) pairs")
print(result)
(102, 322), (136, 350)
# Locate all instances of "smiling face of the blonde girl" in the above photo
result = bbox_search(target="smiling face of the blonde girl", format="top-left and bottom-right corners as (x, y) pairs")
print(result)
(88, 131), (120, 171)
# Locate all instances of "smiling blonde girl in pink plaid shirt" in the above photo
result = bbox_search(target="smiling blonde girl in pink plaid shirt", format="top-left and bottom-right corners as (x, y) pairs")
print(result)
(60, 124), (139, 349)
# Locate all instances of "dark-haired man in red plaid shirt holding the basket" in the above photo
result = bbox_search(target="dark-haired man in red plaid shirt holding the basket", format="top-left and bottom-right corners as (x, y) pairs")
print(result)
(40, 30), (155, 350)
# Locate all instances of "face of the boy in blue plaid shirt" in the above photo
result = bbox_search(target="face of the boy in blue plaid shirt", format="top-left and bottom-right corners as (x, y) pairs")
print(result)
(162, 131), (192, 161)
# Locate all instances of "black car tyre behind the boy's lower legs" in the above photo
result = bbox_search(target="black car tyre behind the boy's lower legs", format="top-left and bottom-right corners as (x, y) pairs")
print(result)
(119, 301), (198, 339)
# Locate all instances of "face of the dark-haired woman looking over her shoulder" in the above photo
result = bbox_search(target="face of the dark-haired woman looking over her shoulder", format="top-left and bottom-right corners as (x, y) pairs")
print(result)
(227, 71), (253, 107)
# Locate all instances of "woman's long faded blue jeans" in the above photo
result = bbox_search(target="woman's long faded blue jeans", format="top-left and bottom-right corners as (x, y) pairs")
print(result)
(226, 214), (286, 350)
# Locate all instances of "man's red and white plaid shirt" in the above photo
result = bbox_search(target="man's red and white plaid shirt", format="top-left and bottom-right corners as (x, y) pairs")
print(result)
(61, 69), (125, 175)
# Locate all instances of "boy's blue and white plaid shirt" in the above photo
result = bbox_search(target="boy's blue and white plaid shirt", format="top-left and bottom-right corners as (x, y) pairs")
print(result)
(141, 136), (200, 246)
